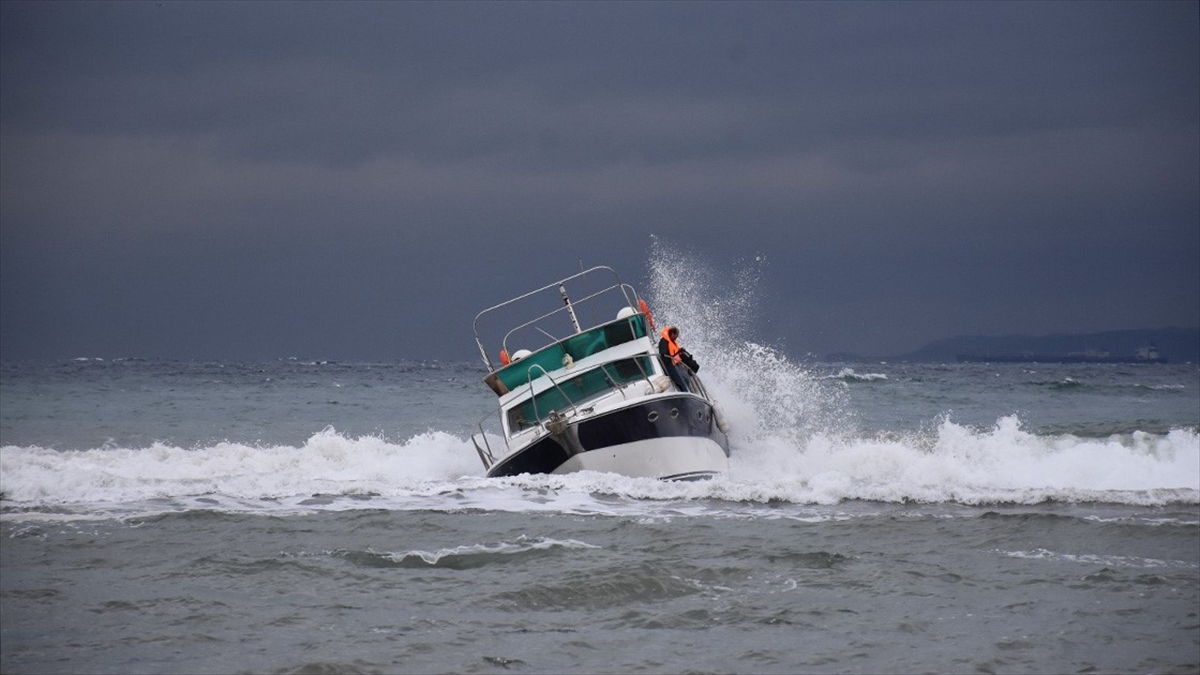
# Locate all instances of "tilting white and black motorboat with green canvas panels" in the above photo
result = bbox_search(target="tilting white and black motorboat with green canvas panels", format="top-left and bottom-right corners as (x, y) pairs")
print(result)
(472, 265), (730, 480)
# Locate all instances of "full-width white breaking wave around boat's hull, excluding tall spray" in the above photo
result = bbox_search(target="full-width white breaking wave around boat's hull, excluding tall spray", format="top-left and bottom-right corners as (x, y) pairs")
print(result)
(0, 417), (1200, 514)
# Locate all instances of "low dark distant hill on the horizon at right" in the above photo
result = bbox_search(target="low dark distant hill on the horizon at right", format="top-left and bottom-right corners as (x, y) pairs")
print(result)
(893, 328), (1200, 363)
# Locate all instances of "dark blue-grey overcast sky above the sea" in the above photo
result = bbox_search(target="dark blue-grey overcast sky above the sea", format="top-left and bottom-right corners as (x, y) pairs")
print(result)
(0, 0), (1200, 360)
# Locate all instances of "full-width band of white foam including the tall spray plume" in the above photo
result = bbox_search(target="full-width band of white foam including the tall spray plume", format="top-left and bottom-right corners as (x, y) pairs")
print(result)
(0, 244), (1200, 520)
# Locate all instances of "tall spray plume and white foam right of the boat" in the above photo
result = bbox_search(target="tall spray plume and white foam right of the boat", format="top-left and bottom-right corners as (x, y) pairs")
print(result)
(638, 238), (1200, 503)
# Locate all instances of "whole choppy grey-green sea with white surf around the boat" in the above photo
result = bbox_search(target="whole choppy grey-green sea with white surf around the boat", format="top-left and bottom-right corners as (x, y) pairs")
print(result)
(0, 260), (1200, 674)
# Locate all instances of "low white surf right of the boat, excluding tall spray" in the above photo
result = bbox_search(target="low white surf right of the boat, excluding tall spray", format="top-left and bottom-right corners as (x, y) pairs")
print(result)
(732, 417), (1200, 503)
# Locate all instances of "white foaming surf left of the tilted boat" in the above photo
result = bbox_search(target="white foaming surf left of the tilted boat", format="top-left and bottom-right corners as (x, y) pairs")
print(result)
(0, 428), (480, 504)
